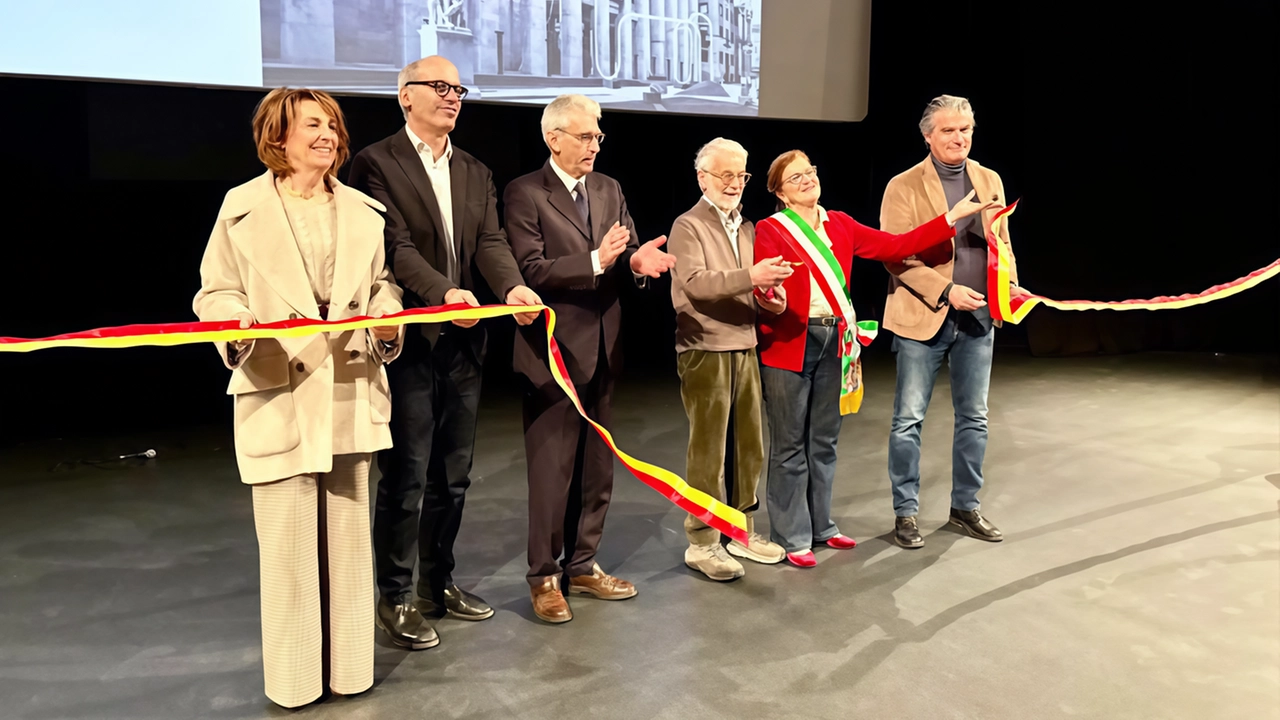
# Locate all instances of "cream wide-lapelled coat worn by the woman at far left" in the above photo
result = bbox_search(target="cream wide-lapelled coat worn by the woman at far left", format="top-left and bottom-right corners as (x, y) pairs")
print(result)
(193, 172), (403, 484)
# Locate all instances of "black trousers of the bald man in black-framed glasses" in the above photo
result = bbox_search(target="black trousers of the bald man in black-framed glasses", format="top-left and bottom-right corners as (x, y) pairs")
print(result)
(374, 328), (483, 603)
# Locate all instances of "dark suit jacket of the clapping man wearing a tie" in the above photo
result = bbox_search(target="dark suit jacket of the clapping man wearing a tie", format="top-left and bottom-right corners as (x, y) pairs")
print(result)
(503, 160), (645, 387)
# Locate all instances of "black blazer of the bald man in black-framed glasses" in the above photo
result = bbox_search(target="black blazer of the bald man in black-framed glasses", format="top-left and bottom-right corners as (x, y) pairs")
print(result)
(348, 129), (525, 347)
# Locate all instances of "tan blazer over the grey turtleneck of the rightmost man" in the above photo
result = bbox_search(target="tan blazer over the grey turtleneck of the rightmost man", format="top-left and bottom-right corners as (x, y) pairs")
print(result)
(881, 156), (1018, 342)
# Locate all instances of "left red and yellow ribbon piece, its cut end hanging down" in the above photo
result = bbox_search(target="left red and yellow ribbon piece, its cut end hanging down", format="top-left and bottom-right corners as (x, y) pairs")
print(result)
(0, 305), (748, 544)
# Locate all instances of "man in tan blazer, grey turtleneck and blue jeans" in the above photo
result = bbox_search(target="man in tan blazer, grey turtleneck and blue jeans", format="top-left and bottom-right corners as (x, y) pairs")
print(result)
(881, 95), (1018, 548)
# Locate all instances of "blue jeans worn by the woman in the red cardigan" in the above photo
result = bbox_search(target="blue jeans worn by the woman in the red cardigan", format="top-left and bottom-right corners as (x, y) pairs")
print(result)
(760, 325), (841, 552)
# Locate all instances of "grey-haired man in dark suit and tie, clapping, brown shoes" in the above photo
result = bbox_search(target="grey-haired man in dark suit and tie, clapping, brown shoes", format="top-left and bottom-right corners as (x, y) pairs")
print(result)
(503, 95), (676, 623)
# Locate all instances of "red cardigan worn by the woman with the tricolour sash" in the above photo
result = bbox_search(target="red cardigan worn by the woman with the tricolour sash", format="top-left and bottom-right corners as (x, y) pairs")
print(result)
(755, 211), (955, 373)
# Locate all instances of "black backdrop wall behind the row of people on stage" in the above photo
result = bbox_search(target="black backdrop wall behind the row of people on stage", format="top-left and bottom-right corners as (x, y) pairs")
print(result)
(0, 0), (1280, 442)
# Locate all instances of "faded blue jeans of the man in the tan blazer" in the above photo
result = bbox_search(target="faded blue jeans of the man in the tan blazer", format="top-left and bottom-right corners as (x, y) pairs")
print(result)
(888, 310), (996, 518)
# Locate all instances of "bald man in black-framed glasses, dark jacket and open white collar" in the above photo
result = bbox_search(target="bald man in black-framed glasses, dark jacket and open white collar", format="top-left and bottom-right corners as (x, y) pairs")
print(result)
(351, 56), (540, 650)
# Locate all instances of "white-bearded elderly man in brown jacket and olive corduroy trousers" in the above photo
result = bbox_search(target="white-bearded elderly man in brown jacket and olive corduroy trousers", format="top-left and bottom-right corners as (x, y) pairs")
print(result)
(668, 137), (792, 582)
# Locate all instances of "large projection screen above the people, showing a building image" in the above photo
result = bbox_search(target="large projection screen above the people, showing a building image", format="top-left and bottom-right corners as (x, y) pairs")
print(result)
(0, 0), (870, 120)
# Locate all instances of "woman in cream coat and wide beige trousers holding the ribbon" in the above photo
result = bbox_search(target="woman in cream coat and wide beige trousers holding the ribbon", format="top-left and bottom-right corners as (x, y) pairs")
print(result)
(195, 88), (402, 707)
